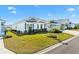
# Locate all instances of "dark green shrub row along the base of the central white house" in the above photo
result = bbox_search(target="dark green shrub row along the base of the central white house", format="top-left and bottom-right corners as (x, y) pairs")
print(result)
(11, 27), (47, 36)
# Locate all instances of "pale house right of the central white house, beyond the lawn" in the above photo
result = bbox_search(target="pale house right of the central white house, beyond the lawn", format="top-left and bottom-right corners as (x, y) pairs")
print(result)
(50, 19), (70, 29)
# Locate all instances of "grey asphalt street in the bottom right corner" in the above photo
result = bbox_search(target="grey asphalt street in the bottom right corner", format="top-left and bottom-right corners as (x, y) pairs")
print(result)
(45, 37), (79, 54)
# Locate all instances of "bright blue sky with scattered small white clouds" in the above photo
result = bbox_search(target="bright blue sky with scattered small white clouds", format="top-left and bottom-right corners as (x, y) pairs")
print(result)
(0, 5), (79, 24)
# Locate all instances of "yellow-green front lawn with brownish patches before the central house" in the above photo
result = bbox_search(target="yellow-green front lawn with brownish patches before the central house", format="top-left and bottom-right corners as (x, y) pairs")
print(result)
(4, 32), (73, 54)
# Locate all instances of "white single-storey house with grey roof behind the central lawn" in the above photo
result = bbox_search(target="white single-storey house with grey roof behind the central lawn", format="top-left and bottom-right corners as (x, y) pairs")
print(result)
(12, 17), (47, 33)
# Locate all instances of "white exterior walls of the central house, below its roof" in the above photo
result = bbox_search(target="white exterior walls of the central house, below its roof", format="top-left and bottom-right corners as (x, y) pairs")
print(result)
(12, 22), (46, 33)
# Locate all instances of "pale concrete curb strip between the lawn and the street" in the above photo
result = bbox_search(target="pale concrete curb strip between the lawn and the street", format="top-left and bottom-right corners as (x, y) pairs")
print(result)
(34, 35), (78, 54)
